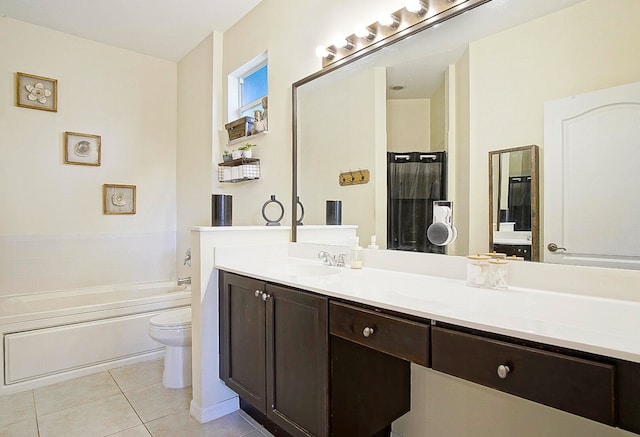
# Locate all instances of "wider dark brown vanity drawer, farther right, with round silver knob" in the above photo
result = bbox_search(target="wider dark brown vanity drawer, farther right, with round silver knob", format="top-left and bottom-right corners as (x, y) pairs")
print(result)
(431, 327), (615, 425)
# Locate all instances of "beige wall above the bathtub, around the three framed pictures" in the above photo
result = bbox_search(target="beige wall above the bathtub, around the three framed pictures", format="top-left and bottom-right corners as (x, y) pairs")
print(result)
(0, 17), (177, 294)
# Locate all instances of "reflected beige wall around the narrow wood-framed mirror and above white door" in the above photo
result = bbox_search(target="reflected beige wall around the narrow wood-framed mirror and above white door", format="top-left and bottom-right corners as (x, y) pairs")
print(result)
(469, 0), (640, 252)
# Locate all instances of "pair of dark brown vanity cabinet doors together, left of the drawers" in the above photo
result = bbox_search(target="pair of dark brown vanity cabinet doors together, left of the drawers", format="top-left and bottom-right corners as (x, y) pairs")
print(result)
(220, 273), (329, 436)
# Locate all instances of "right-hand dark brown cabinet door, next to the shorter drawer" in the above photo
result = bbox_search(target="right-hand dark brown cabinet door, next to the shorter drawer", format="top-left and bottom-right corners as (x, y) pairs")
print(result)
(266, 284), (328, 436)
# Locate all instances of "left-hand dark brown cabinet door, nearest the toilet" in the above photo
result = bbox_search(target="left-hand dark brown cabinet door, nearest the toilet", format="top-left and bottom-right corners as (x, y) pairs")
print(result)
(220, 273), (266, 414)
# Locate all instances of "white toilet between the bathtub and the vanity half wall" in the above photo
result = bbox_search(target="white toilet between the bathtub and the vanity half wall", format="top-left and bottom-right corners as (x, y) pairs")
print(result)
(149, 307), (191, 388)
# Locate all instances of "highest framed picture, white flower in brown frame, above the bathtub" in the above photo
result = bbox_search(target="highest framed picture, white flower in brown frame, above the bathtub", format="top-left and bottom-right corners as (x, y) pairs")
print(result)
(16, 73), (58, 112)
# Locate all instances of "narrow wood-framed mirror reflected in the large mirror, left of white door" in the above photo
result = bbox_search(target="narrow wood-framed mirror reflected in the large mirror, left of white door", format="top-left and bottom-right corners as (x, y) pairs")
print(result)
(489, 146), (540, 261)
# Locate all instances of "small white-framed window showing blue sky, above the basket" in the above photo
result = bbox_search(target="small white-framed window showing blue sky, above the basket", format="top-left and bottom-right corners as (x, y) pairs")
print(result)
(228, 52), (269, 121)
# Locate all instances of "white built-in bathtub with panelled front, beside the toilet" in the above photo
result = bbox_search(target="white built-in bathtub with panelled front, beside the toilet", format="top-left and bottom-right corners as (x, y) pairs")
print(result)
(0, 282), (191, 394)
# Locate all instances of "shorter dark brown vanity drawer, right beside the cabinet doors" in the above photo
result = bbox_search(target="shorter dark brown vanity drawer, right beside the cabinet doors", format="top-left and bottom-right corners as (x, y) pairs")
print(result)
(329, 302), (429, 366)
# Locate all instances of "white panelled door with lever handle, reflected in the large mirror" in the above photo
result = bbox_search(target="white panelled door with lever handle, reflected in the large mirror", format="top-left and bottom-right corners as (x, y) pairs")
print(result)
(543, 82), (640, 269)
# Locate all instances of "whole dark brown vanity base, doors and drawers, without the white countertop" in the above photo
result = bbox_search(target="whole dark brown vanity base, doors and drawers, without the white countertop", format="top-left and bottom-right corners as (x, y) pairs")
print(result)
(220, 272), (640, 437)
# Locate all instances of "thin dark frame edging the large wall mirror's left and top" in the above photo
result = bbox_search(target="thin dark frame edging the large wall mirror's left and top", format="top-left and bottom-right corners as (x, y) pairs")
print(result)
(291, 0), (491, 242)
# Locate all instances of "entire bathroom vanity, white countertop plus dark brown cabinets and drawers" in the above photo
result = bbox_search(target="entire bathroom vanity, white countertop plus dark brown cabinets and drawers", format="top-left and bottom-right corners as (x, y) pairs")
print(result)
(216, 245), (640, 436)
